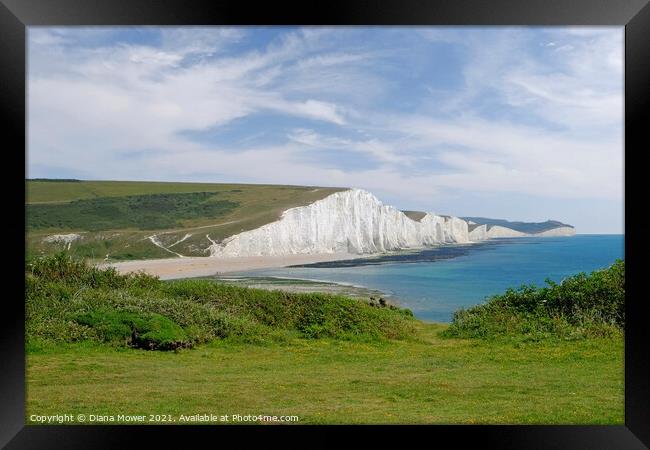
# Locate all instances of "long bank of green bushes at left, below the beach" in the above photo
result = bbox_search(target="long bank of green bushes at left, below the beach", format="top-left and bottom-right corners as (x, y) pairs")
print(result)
(25, 253), (414, 350)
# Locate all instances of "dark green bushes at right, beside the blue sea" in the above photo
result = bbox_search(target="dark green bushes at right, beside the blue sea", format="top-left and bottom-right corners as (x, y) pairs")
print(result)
(446, 260), (625, 339)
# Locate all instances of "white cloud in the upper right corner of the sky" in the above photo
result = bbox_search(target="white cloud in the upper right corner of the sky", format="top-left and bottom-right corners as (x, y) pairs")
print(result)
(503, 29), (623, 135)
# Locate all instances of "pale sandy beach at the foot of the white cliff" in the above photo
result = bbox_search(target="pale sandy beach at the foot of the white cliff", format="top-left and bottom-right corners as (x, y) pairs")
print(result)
(99, 253), (360, 280)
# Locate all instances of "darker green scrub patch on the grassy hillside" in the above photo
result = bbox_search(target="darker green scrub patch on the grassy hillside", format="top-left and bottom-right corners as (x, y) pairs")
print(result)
(27, 192), (239, 231)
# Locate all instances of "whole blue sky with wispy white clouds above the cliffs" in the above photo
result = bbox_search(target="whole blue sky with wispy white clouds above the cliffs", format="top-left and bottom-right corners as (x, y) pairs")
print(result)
(27, 27), (624, 233)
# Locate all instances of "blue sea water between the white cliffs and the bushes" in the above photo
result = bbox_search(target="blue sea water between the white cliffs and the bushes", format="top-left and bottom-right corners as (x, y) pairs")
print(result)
(241, 235), (624, 322)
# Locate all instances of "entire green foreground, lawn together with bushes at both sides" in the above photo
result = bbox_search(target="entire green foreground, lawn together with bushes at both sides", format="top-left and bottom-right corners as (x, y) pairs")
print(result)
(26, 254), (624, 424)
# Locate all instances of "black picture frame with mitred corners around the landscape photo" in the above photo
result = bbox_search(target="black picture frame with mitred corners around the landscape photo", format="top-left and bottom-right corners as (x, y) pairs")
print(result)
(0, 0), (650, 449)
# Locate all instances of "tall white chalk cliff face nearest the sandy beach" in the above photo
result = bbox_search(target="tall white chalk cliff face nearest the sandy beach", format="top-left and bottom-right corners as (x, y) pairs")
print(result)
(209, 189), (470, 257)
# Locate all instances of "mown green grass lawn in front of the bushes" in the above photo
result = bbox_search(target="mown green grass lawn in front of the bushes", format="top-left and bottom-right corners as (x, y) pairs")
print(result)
(26, 322), (624, 424)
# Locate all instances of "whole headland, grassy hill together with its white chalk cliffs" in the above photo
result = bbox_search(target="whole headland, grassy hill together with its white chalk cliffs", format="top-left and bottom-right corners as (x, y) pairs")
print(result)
(25, 179), (575, 262)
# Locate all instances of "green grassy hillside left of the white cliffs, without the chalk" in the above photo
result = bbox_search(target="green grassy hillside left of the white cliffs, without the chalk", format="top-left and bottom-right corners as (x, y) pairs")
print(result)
(26, 179), (344, 260)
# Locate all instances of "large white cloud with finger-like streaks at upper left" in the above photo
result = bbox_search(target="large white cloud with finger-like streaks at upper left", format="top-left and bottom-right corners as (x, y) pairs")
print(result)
(28, 26), (354, 164)
